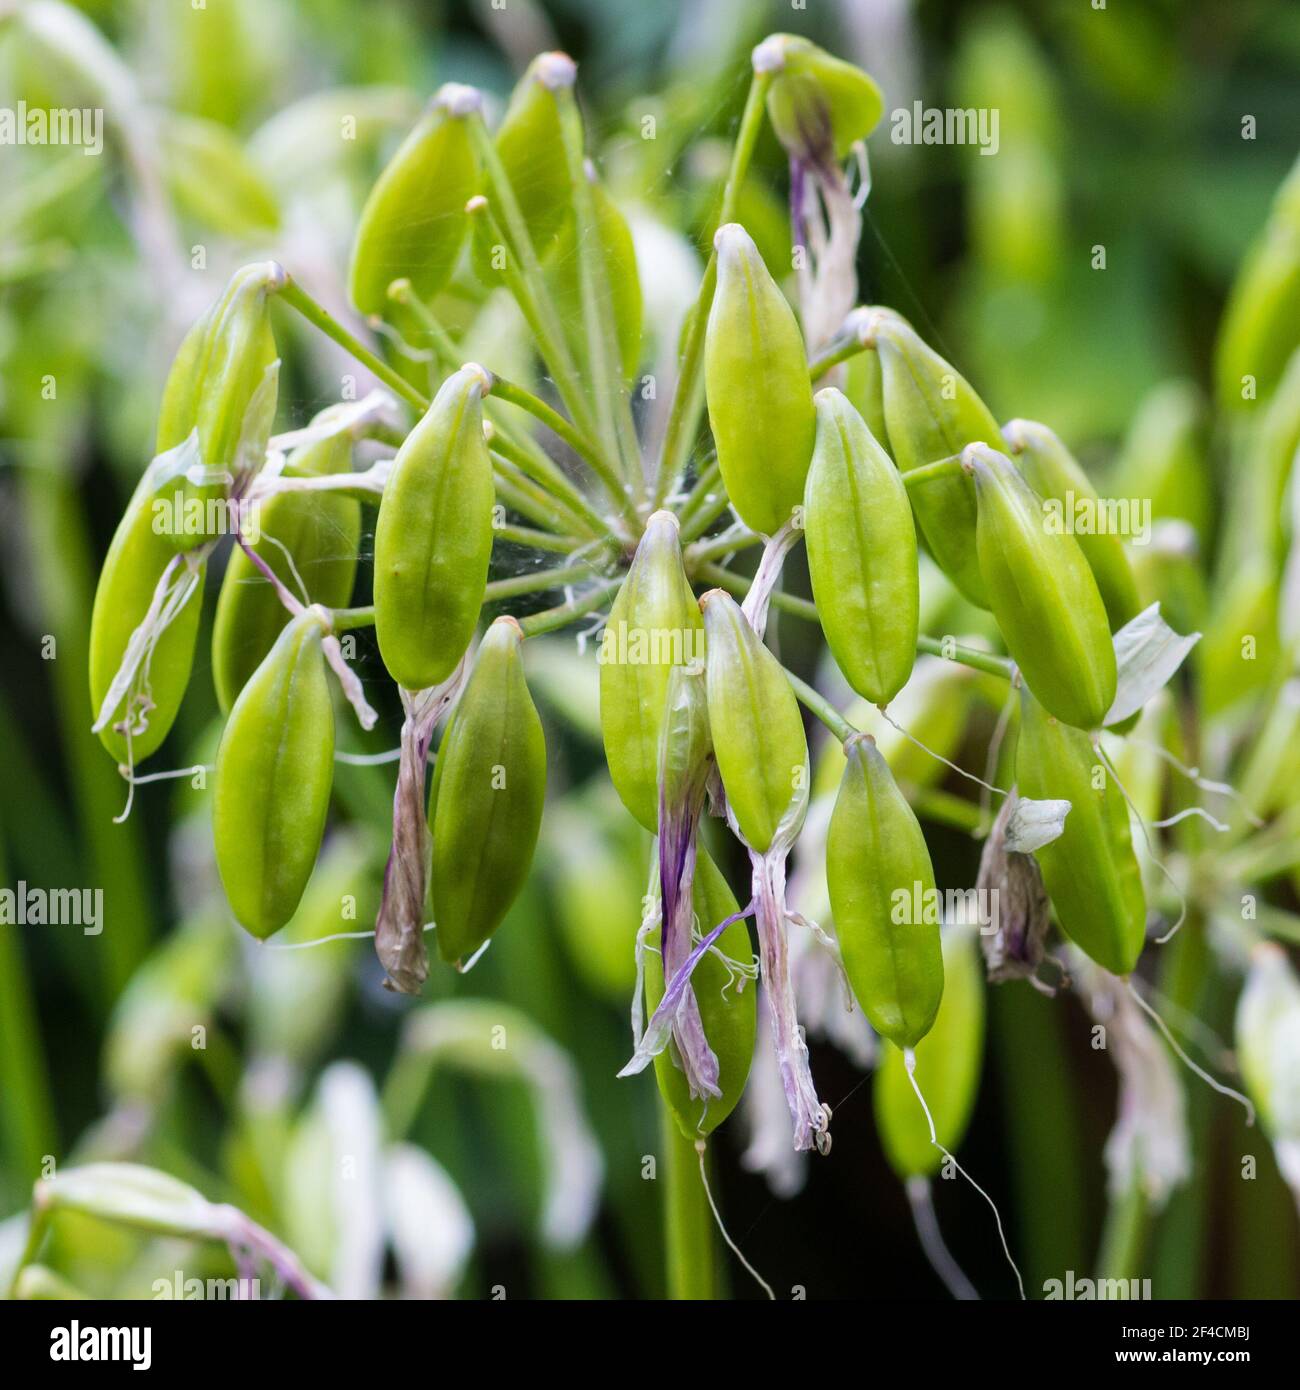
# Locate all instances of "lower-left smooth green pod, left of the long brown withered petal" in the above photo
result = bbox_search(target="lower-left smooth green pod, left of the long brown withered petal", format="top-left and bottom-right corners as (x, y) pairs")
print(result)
(213, 609), (334, 941)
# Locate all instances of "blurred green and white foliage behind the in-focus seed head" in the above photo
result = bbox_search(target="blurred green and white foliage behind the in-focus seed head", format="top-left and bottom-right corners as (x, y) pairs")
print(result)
(0, 0), (1300, 1297)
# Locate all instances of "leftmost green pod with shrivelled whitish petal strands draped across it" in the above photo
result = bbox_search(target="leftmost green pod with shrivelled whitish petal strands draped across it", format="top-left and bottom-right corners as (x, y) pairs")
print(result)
(90, 458), (203, 763)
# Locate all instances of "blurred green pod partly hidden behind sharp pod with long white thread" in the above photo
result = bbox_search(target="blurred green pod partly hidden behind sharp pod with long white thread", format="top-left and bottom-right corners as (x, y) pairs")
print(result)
(873, 926), (984, 1182)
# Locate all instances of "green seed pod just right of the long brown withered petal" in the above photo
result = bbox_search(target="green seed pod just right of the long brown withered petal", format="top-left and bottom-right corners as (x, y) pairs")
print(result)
(428, 617), (546, 962)
